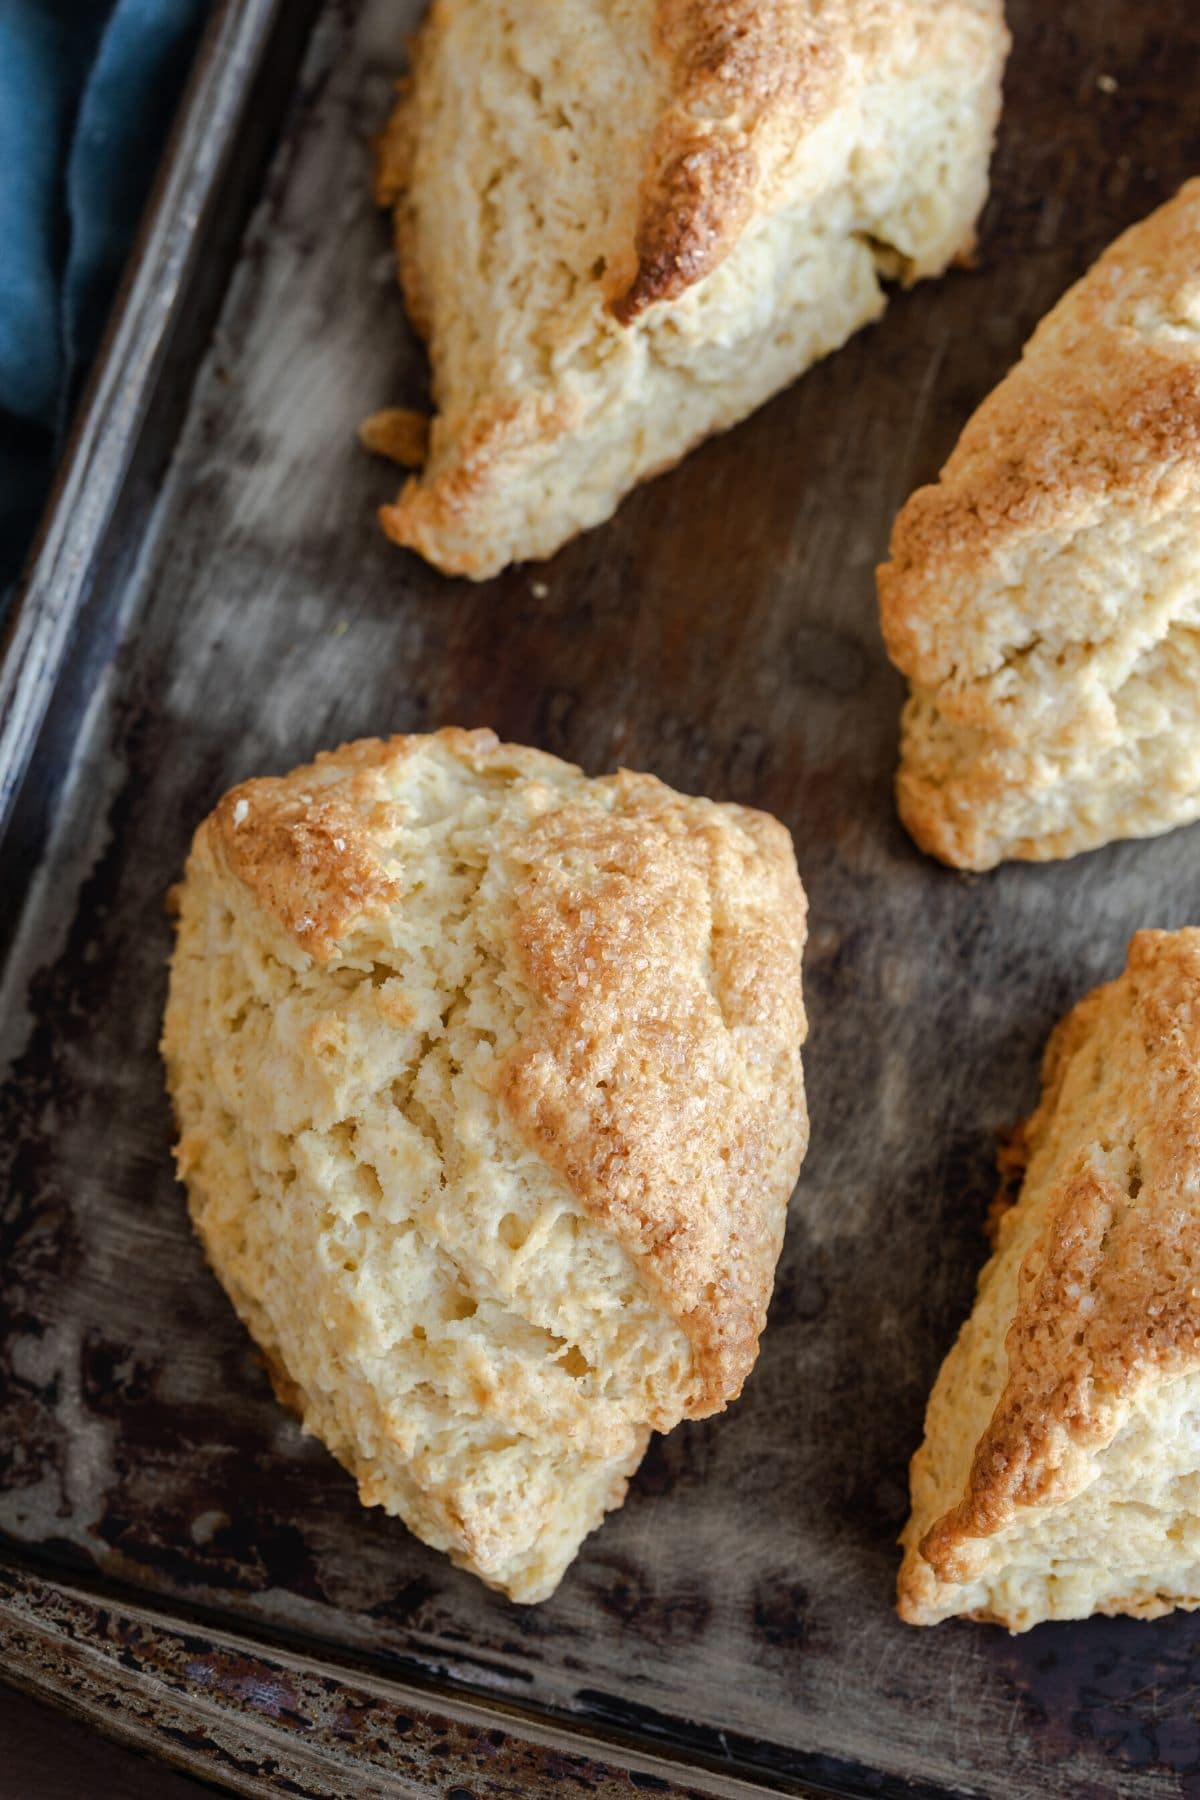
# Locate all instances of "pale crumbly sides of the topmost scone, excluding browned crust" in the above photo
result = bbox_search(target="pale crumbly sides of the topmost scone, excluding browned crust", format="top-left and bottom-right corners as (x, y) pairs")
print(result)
(383, 0), (997, 572)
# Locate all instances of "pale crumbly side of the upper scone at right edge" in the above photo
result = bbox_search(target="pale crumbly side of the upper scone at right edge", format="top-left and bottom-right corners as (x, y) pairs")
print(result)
(900, 495), (1200, 868)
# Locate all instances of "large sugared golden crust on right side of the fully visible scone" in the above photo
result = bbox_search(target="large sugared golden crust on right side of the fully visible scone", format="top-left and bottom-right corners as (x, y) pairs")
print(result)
(502, 774), (806, 1415)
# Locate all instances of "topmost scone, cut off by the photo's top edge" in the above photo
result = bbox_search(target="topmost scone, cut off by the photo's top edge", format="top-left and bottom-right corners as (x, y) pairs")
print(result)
(365, 0), (1007, 578)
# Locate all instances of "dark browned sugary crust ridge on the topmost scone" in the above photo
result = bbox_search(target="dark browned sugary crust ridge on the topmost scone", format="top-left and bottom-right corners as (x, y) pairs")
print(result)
(610, 0), (842, 324)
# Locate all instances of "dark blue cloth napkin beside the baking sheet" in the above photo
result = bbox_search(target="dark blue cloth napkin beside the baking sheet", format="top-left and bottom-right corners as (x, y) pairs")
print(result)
(0, 0), (210, 601)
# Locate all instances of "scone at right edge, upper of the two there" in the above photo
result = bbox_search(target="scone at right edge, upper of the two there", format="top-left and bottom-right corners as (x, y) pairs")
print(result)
(880, 182), (1200, 869)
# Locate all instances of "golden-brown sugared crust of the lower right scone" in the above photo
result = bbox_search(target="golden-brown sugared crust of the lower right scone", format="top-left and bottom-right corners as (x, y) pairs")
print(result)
(900, 929), (1200, 1598)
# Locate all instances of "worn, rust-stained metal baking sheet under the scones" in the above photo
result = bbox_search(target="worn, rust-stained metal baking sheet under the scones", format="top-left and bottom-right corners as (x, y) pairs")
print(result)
(0, 0), (1200, 1800)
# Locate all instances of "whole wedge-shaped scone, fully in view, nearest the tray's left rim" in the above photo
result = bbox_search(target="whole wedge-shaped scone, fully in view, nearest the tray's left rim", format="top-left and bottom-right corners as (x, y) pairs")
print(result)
(164, 731), (808, 1600)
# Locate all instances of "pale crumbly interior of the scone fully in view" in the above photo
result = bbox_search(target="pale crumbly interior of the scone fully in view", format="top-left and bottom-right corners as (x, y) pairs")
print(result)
(167, 752), (693, 1600)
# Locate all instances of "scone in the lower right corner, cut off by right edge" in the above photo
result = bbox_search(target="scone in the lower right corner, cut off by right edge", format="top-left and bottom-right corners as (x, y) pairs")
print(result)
(900, 931), (1200, 1631)
